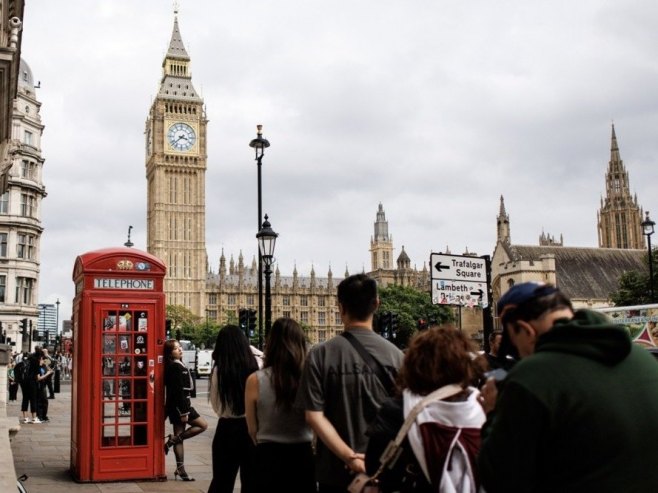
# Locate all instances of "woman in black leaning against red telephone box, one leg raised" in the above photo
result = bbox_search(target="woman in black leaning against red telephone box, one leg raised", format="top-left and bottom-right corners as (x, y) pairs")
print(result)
(164, 339), (208, 481)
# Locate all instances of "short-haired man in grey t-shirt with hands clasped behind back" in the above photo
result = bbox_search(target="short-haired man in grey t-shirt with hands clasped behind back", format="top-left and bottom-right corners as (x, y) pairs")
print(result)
(297, 274), (403, 493)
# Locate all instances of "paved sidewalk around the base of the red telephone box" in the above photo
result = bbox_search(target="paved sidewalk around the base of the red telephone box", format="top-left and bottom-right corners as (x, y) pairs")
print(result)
(7, 379), (228, 493)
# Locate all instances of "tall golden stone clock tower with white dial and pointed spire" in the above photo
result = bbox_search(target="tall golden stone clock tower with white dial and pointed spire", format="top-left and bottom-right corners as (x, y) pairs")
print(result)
(145, 17), (208, 316)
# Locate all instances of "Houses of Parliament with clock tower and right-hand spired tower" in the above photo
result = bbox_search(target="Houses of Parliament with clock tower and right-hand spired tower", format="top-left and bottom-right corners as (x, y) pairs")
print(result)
(145, 13), (644, 342)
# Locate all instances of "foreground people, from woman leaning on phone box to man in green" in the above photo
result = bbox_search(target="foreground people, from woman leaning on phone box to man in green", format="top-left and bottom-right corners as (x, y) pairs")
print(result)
(165, 274), (658, 493)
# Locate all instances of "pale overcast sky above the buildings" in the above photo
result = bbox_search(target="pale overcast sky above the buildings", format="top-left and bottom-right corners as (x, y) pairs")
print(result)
(22, 0), (658, 320)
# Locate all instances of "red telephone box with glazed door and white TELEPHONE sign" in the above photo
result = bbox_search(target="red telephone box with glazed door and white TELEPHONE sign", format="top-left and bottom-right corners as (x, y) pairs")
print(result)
(71, 248), (166, 482)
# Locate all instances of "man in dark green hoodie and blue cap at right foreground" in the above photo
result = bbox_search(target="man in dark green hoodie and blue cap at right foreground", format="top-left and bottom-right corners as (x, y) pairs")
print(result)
(478, 283), (658, 493)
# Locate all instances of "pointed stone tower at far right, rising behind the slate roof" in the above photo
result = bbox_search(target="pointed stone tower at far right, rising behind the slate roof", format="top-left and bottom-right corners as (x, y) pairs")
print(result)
(597, 125), (645, 249)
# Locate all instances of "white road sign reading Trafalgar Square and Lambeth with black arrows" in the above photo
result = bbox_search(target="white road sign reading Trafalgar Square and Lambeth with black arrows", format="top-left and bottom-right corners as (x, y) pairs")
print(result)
(430, 253), (489, 308)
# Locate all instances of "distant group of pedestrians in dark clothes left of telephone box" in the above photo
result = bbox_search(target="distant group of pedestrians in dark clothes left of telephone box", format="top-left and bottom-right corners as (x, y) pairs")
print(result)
(7, 346), (73, 424)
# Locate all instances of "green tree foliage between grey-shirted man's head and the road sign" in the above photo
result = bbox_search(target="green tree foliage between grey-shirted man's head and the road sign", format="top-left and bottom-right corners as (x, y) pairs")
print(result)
(377, 285), (453, 348)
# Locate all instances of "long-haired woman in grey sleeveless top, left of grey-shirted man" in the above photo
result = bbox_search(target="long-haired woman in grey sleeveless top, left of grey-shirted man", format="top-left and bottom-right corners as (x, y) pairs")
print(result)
(245, 318), (316, 493)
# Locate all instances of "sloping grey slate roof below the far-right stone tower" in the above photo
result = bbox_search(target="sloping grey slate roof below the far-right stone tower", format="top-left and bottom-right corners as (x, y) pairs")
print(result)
(511, 245), (647, 299)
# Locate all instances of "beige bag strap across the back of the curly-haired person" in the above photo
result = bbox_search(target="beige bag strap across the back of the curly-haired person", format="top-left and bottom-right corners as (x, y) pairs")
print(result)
(347, 384), (464, 493)
